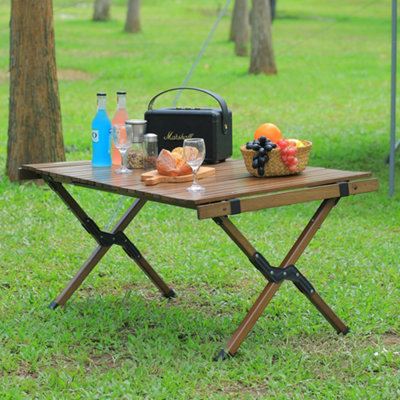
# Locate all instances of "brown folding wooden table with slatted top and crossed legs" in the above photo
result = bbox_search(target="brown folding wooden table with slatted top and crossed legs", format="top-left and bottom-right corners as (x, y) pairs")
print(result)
(20, 160), (378, 360)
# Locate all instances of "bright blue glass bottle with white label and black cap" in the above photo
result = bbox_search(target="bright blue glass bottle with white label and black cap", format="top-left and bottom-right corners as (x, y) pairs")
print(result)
(92, 93), (111, 167)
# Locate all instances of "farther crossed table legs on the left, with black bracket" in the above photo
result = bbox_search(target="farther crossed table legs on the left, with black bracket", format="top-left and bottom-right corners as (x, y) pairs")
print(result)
(46, 178), (175, 309)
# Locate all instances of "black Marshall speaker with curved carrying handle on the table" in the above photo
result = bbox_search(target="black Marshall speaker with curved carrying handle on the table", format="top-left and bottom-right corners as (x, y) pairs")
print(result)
(144, 88), (232, 164)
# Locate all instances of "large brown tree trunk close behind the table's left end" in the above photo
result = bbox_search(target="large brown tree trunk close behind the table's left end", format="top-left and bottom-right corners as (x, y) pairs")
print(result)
(6, 0), (65, 181)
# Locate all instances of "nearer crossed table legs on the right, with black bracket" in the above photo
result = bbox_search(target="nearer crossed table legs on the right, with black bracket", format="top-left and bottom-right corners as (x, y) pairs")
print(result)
(214, 199), (349, 360)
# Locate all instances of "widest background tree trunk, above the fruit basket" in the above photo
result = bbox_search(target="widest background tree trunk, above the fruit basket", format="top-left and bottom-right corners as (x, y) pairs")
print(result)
(249, 0), (277, 75)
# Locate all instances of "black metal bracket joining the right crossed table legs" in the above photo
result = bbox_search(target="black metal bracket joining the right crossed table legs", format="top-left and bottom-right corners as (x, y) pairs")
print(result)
(250, 253), (315, 295)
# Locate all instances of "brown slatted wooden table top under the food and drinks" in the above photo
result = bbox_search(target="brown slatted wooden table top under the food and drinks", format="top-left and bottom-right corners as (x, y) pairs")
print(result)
(20, 159), (377, 214)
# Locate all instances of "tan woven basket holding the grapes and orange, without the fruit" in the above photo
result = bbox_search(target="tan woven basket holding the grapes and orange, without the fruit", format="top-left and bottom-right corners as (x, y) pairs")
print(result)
(240, 140), (312, 178)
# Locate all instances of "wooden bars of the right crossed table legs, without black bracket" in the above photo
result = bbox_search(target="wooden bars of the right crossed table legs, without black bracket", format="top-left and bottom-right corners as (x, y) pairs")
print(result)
(214, 199), (349, 360)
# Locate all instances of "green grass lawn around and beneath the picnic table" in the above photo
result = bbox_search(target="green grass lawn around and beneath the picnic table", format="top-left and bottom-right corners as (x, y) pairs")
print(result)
(0, 0), (400, 400)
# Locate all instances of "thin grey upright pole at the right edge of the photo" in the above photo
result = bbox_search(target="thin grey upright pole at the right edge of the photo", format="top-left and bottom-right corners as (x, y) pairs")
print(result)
(389, 0), (397, 197)
